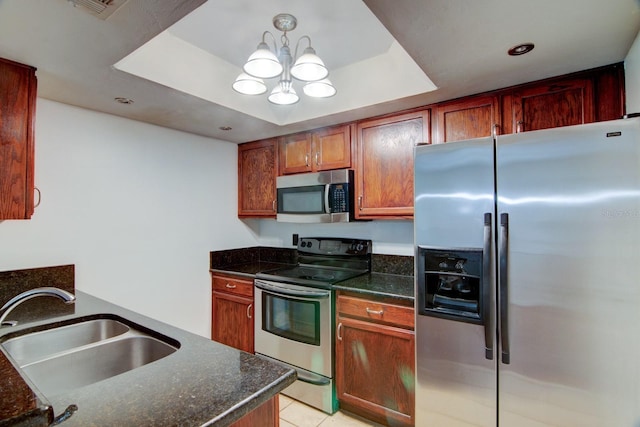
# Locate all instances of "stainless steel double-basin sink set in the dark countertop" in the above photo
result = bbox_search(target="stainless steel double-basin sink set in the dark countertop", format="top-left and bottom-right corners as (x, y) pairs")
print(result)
(0, 316), (180, 396)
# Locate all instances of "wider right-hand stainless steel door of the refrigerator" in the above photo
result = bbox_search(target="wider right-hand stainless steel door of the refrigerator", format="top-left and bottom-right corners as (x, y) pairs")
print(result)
(497, 120), (640, 427)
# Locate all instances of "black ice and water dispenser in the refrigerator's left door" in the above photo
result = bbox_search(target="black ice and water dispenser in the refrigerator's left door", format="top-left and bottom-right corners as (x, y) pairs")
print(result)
(417, 247), (488, 324)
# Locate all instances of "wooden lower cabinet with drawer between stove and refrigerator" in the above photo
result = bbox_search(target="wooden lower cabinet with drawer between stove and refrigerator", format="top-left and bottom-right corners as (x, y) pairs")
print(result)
(336, 294), (415, 426)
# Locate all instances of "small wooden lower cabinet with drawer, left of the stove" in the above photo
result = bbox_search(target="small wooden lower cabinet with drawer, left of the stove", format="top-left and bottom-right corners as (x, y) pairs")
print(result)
(211, 274), (254, 353)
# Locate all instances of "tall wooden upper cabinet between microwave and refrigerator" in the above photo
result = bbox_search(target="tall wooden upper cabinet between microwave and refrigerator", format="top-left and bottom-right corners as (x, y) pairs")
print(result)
(355, 110), (430, 219)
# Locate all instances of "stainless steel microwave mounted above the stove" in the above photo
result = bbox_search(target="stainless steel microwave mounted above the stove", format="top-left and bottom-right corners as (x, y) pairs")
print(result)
(276, 169), (354, 223)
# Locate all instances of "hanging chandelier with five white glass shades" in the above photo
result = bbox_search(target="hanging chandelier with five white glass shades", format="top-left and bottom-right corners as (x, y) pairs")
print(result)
(232, 13), (336, 105)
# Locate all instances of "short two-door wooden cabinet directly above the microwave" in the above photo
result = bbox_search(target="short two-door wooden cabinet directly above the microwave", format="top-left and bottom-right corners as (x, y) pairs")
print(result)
(278, 125), (352, 175)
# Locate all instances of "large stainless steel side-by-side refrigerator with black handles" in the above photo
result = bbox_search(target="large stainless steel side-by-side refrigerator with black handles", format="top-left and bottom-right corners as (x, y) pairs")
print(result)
(414, 119), (640, 427)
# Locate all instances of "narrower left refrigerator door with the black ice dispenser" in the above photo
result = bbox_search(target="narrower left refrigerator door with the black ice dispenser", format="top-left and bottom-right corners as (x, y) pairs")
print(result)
(414, 138), (497, 427)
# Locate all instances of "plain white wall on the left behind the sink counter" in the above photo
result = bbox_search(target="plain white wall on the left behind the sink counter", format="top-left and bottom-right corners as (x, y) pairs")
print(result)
(0, 99), (257, 336)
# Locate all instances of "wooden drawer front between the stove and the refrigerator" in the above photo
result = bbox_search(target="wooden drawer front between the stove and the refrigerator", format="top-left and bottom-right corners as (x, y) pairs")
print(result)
(337, 295), (415, 329)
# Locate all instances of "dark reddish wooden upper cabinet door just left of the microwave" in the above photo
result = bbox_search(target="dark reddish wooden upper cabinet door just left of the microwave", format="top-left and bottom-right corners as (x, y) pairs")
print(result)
(238, 139), (276, 218)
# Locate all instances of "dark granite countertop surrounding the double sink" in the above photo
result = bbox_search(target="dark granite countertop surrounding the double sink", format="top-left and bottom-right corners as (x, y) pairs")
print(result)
(0, 291), (296, 426)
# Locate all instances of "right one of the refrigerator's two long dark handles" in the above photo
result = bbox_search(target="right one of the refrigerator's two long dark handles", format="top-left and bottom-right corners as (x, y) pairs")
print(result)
(498, 213), (511, 365)
